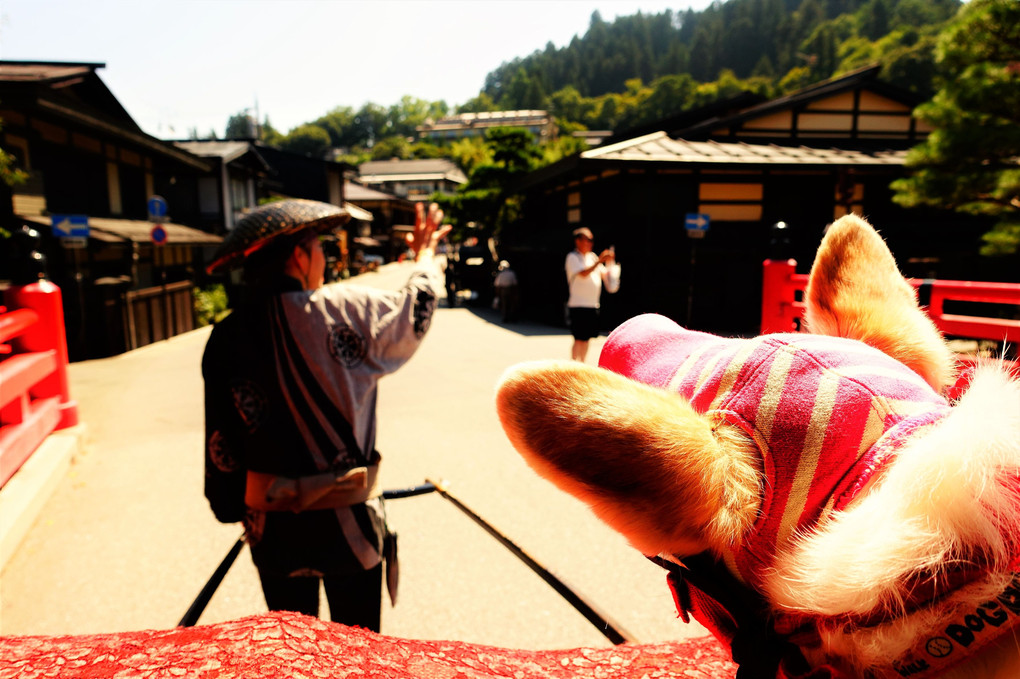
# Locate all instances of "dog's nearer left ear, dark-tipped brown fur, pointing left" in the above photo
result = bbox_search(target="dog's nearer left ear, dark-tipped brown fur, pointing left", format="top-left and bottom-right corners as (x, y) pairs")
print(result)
(497, 361), (759, 556)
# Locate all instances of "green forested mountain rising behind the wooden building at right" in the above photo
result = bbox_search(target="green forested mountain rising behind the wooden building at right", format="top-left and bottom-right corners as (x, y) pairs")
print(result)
(473, 0), (962, 128)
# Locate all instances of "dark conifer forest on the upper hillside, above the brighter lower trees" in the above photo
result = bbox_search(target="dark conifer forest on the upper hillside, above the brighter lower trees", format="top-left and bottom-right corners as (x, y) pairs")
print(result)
(482, 0), (961, 106)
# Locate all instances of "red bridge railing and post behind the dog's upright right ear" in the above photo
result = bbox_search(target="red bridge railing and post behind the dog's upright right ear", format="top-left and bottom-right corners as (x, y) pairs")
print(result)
(761, 259), (1020, 345)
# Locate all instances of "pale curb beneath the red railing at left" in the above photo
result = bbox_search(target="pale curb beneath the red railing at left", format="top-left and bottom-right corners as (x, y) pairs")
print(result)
(0, 424), (86, 572)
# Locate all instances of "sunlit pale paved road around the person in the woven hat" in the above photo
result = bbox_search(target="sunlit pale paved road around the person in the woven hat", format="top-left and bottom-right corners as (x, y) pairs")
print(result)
(0, 265), (705, 648)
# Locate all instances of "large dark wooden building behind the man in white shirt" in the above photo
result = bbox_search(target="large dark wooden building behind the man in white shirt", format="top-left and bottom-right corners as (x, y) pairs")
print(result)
(500, 67), (989, 333)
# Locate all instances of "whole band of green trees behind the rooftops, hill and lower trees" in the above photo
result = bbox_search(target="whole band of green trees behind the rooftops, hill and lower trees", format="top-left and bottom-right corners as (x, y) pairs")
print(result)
(226, 0), (962, 166)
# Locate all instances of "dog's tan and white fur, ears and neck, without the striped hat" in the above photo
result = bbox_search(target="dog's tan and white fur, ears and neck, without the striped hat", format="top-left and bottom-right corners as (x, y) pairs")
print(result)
(497, 216), (1020, 678)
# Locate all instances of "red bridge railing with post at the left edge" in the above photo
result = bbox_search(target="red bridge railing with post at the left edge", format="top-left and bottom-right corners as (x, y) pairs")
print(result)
(0, 280), (78, 487)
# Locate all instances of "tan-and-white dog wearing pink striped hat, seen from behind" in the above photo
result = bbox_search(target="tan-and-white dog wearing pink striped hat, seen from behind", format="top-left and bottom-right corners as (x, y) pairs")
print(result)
(496, 215), (1020, 679)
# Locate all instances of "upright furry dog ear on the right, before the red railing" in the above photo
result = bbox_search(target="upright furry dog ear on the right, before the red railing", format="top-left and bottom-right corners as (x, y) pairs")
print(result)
(805, 215), (954, 390)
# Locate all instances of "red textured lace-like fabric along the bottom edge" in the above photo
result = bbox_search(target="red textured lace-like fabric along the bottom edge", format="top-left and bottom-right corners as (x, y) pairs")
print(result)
(0, 613), (736, 679)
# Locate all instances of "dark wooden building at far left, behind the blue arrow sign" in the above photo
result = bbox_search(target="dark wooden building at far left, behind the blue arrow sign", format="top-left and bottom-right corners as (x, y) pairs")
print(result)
(0, 61), (221, 360)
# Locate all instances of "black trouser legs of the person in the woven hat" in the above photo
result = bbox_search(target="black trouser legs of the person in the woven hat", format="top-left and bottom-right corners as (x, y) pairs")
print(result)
(259, 564), (383, 632)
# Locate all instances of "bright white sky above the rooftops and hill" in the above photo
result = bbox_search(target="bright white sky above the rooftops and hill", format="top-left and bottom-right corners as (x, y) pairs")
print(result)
(0, 0), (710, 139)
